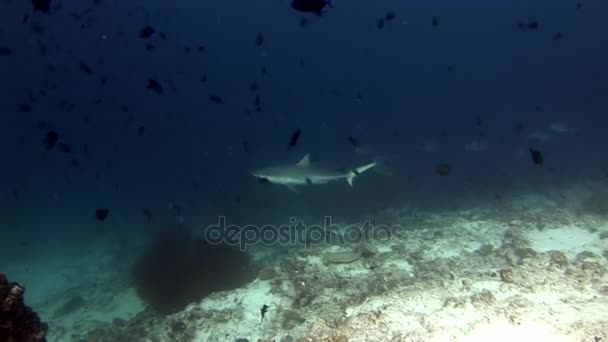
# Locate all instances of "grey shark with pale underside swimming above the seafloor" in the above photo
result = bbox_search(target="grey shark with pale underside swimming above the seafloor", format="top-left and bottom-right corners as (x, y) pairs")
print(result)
(251, 154), (376, 192)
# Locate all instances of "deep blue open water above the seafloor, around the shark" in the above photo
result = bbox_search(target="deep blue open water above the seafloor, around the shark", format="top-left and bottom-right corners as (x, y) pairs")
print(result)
(0, 0), (608, 262)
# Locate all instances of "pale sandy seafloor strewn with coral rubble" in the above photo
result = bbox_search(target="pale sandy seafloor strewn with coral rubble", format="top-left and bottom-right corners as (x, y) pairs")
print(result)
(2, 180), (608, 342)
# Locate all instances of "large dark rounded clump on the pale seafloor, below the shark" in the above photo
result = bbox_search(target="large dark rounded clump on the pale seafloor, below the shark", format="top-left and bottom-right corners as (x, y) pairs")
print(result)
(132, 227), (255, 314)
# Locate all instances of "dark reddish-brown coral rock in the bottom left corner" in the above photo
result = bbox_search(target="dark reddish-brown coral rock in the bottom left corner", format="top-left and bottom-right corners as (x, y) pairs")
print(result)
(0, 273), (48, 342)
